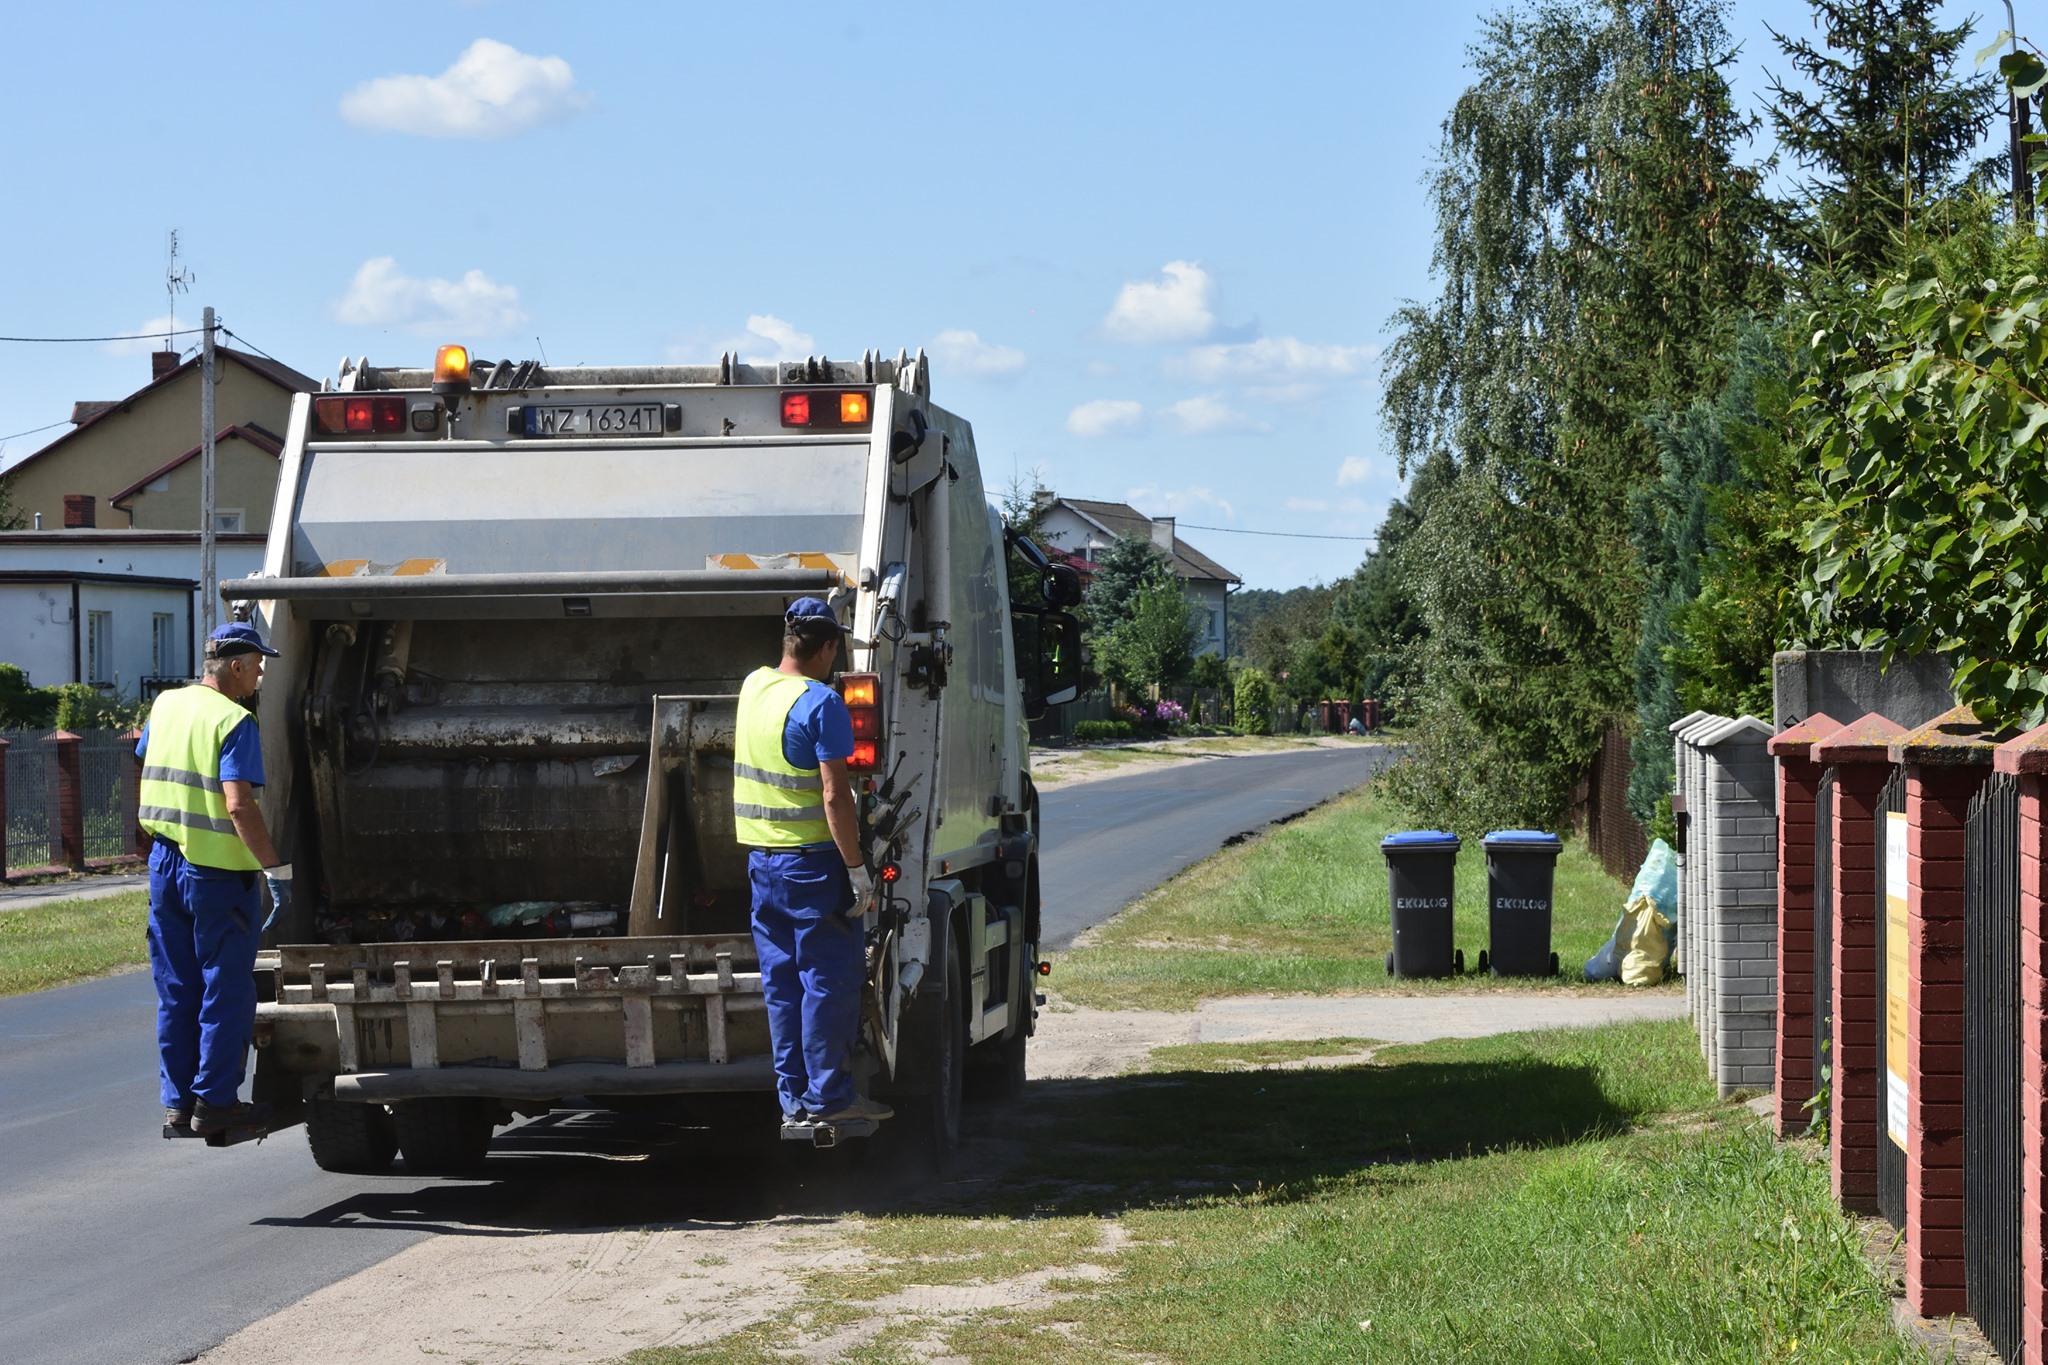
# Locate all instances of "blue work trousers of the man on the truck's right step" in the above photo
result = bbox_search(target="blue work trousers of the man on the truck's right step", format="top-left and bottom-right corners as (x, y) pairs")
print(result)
(748, 845), (866, 1117)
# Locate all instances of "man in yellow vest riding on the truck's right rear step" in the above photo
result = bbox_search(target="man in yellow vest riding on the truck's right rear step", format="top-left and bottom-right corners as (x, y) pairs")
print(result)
(733, 598), (891, 1121)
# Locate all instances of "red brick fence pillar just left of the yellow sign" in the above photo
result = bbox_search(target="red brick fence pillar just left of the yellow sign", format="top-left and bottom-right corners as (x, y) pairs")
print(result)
(1812, 712), (1905, 1214)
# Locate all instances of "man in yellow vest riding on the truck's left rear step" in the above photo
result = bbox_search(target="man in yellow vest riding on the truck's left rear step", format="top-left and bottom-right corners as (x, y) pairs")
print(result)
(135, 622), (291, 1138)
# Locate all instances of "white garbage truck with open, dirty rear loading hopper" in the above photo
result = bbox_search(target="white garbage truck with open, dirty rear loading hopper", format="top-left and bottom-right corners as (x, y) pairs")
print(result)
(221, 346), (1081, 1173)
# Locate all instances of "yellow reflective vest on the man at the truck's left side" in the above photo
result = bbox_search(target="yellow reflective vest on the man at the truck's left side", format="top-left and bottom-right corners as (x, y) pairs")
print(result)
(137, 684), (262, 872)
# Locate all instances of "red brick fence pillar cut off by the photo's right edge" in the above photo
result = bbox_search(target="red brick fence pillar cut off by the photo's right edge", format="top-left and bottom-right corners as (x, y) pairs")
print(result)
(1997, 724), (2048, 1361)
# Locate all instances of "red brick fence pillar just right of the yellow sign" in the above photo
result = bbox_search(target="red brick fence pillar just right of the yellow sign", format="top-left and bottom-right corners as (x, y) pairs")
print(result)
(1878, 706), (2001, 1318)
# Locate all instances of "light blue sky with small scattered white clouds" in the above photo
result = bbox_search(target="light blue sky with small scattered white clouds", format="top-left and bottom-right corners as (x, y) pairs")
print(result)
(0, 0), (2007, 587)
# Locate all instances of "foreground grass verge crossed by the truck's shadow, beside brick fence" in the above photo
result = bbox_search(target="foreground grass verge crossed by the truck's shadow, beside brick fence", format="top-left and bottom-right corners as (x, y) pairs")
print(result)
(629, 1021), (1923, 1365)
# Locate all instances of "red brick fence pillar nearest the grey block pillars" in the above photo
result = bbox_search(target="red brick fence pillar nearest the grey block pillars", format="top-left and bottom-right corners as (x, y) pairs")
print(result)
(1769, 712), (1841, 1138)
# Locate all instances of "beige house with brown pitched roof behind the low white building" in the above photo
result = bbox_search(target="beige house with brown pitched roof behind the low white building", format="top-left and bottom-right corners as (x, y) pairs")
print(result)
(0, 346), (319, 532)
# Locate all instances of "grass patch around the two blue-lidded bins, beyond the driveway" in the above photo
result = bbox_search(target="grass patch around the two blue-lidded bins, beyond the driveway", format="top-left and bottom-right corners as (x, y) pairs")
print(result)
(1053, 786), (1628, 1009)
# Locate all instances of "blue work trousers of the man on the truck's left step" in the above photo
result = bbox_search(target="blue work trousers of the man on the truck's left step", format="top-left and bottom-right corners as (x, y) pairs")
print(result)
(150, 839), (262, 1109)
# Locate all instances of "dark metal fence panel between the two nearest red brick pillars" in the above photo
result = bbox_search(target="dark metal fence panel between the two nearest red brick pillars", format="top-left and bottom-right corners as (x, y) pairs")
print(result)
(1962, 774), (2023, 1361)
